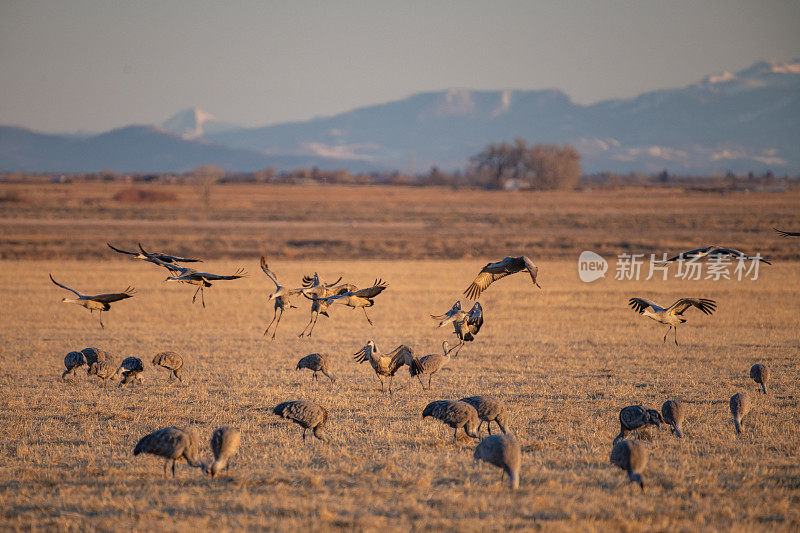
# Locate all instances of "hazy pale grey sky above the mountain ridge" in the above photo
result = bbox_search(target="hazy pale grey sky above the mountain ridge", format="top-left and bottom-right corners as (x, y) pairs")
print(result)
(0, 0), (800, 132)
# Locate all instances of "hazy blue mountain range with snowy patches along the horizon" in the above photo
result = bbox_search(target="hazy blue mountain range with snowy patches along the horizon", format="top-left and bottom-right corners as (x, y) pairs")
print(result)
(0, 61), (800, 175)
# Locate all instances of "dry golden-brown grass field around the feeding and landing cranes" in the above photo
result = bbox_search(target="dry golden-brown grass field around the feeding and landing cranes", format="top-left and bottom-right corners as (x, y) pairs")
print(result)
(0, 186), (800, 531)
